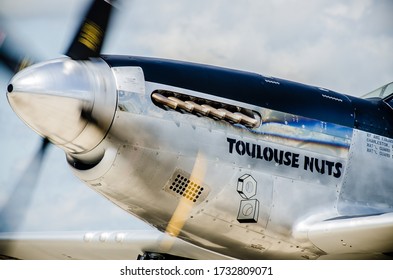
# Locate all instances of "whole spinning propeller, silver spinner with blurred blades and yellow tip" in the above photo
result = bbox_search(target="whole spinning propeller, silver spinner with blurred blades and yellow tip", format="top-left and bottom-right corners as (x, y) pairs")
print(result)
(0, 0), (206, 258)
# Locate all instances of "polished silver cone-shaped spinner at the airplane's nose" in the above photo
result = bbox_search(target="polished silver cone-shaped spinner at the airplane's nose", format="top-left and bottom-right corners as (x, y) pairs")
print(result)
(7, 58), (117, 153)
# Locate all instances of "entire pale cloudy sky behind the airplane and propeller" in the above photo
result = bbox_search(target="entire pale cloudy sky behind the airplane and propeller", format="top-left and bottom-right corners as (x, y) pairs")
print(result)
(0, 0), (393, 231)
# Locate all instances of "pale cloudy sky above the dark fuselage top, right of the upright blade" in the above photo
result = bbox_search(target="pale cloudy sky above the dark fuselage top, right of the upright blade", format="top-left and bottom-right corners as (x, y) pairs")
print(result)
(102, 0), (393, 95)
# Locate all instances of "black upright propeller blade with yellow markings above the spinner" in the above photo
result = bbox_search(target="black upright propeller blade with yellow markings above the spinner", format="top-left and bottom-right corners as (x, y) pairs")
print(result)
(66, 0), (113, 60)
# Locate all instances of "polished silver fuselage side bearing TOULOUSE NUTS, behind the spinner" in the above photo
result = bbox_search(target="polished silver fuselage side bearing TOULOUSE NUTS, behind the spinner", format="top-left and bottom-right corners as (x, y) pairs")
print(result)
(6, 57), (393, 259)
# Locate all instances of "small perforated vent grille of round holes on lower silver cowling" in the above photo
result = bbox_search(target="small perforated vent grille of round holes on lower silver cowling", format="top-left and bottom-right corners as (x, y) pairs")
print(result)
(164, 169), (209, 204)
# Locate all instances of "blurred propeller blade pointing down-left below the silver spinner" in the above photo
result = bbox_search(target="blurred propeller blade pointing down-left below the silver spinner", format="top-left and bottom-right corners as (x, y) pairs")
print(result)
(0, 138), (49, 232)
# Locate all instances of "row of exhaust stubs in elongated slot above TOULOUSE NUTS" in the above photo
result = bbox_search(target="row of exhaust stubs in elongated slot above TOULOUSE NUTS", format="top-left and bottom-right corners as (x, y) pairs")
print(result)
(151, 90), (261, 128)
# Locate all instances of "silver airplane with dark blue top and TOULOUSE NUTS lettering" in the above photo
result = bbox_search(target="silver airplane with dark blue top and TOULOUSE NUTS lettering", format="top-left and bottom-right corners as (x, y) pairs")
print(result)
(0, 0), (393, 259)
